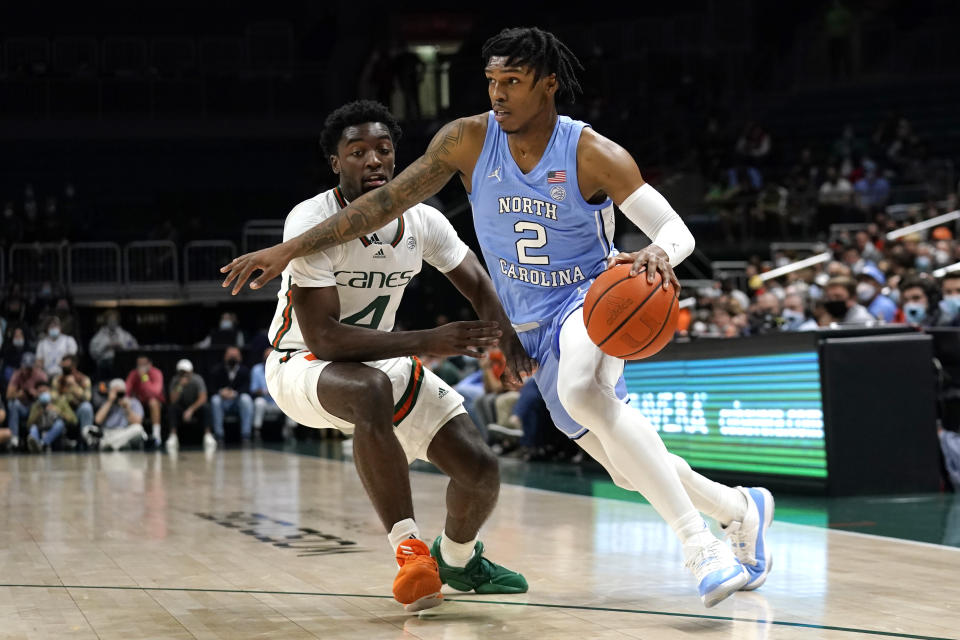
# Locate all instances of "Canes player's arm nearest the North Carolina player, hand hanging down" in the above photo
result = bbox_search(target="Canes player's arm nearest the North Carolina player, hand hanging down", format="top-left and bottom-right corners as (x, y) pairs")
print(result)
(446, 251), (536, 387)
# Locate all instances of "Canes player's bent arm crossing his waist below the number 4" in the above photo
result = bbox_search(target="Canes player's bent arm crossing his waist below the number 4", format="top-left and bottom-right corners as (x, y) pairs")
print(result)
(291, 285), (501, 362)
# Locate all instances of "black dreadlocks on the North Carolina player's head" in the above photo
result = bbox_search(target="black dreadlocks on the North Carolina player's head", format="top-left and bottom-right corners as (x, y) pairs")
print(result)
(482, 27), (583, 102)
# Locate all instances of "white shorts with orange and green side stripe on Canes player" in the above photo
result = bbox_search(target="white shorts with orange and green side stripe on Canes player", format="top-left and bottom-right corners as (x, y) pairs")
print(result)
(265, 350), (466, 463)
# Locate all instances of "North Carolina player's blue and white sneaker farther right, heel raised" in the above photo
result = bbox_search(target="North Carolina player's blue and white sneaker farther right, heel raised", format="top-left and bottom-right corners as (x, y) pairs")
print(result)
(723, 487), (774, 591)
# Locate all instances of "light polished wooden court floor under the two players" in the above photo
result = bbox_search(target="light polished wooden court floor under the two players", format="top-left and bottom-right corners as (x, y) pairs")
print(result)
(0, 448), (960, 640)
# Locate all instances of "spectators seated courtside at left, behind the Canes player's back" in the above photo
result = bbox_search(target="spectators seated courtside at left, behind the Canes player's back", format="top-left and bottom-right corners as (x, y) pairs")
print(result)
(0, 283), (296, 452)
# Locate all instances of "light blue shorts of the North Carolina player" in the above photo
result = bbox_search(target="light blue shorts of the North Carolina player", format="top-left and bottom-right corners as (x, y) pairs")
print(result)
(517, 280), (627, 440)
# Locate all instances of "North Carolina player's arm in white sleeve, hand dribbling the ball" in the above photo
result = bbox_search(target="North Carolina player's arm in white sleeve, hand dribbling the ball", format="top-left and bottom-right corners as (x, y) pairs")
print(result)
(577, 129), (694, 290)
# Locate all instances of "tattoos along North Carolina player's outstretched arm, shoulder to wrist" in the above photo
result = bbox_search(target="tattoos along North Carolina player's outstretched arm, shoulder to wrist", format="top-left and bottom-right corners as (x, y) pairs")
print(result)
(295, 120), (463, 257)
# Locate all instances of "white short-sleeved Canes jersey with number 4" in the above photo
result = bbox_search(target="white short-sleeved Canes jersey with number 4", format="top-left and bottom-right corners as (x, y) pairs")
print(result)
(268, 186), (468, 351)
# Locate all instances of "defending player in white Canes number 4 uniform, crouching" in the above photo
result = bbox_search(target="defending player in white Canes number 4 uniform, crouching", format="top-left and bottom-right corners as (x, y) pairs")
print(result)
(265, 100), (527, 611)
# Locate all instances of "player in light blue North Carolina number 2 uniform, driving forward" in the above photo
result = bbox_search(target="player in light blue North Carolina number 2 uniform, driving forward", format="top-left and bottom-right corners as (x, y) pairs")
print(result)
(222, 28), (774, 607)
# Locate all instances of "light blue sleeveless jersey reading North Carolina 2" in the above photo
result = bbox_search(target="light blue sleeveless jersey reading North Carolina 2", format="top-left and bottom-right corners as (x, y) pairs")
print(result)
(470, 111), (614, 326)
